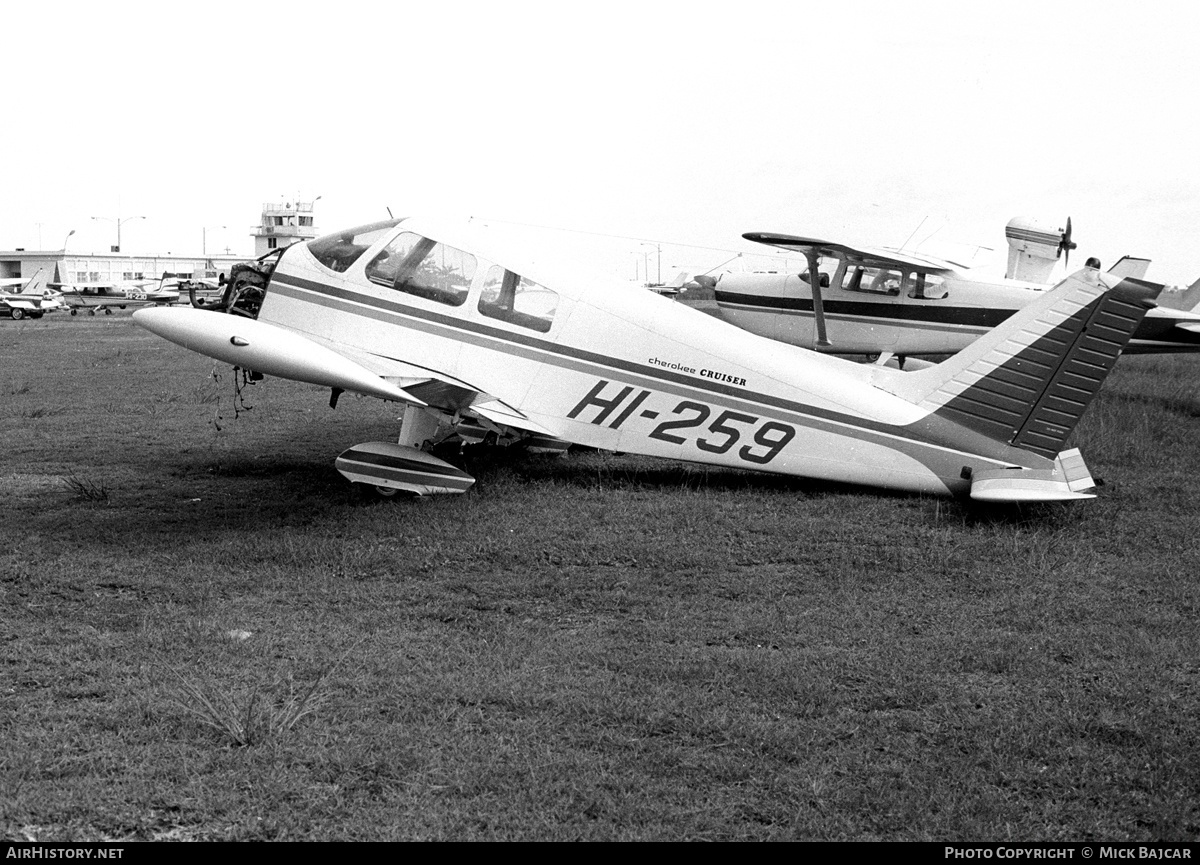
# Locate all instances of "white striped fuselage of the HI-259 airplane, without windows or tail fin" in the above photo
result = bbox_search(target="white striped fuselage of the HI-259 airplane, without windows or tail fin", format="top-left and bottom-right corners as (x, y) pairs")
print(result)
(258, 222), (1070, 494)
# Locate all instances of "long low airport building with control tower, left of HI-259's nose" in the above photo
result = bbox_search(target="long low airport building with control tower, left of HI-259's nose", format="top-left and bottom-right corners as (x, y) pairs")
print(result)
(0, 202), (317, 283)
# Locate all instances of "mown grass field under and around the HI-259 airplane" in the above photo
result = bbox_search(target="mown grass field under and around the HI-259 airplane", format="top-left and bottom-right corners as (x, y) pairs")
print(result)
(0, 313), (1200, 841)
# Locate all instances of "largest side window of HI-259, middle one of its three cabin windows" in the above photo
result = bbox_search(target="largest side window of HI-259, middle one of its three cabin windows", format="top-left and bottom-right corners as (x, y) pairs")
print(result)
(366, 232), (476, 306)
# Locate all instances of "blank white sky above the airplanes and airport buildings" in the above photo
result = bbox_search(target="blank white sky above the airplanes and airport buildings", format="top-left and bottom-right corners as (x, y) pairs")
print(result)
(9, 0), (1200, 283)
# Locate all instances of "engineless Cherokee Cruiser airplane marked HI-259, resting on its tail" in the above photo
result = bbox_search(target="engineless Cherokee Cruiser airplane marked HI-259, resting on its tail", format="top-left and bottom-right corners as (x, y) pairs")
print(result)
(133, 212), (1162, 501)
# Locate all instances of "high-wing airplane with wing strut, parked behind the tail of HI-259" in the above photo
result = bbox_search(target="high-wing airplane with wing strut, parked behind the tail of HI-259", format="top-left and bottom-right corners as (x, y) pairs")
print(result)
(700, 217), (1200, 366)
